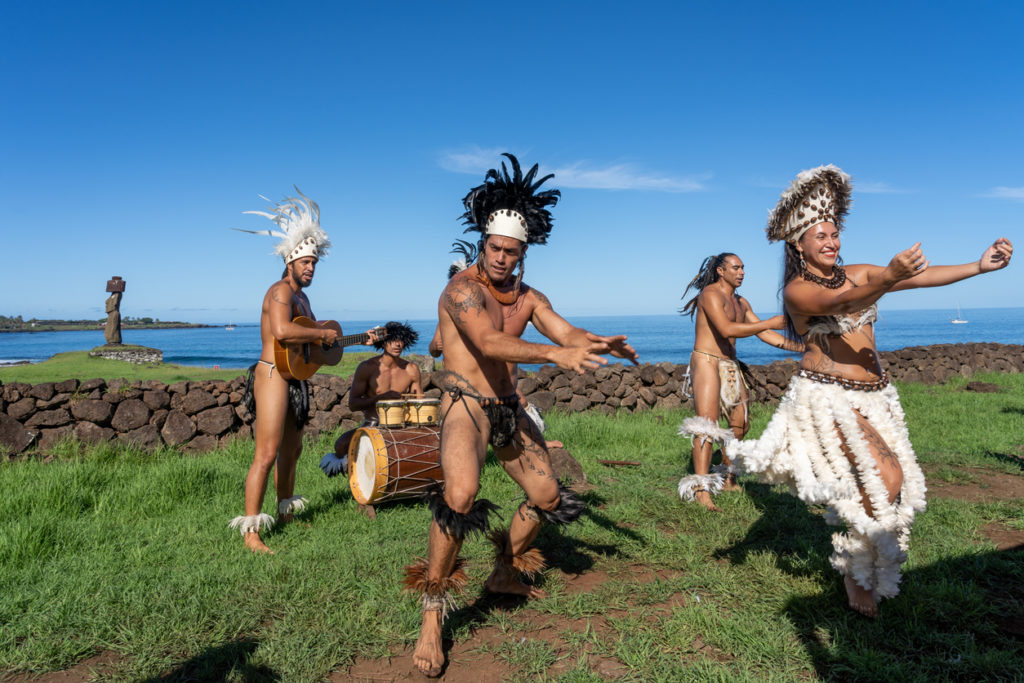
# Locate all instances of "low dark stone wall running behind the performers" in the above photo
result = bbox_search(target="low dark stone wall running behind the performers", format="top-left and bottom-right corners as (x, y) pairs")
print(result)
(0, 343), (1024, 455)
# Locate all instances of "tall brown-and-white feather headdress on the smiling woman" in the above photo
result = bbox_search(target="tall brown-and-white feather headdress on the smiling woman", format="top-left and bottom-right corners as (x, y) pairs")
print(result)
(765, 164), (852, 242)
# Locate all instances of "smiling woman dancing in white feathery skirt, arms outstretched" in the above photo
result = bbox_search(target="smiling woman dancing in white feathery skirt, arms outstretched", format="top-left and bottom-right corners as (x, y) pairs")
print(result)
(726, 166), (1013, 616)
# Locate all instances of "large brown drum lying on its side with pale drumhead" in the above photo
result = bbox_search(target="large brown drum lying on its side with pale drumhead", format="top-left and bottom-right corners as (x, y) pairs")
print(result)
(348, 427), (444, 505)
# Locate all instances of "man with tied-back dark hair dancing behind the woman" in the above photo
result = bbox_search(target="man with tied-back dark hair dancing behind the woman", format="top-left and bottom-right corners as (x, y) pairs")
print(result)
(679, 252), (804, 512)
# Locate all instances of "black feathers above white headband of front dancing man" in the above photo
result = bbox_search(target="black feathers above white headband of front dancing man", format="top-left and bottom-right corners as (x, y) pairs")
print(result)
(462, 153), (562, 245)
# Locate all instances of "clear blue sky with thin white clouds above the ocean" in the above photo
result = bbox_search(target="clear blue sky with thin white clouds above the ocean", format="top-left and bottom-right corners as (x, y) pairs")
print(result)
(0, 1), (1024, 323)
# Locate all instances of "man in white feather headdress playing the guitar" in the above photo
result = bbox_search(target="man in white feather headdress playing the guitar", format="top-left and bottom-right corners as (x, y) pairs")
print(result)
(228, 187), (376, 553)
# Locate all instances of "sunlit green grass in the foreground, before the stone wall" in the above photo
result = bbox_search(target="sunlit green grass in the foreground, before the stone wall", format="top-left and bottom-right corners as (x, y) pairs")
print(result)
(0, 375), (1024, 681)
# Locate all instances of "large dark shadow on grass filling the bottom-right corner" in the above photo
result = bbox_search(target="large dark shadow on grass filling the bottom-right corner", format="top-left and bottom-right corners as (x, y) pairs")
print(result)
(783, 541), (1024, 681)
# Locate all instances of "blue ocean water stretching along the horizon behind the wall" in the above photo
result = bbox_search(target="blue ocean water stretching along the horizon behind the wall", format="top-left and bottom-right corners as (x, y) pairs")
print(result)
(0, 308), (1024, 368)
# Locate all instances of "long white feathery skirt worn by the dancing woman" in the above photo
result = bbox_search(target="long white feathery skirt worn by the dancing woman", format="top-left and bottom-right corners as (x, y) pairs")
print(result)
(725, 372), (927, 598)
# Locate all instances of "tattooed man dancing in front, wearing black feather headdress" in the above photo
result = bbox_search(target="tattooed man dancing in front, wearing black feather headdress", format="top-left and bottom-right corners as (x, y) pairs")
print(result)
(406, 155), (637, 676)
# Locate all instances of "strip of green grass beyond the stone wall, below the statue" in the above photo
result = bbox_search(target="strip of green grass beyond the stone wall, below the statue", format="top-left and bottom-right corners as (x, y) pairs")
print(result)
(0, 351), (374, 384)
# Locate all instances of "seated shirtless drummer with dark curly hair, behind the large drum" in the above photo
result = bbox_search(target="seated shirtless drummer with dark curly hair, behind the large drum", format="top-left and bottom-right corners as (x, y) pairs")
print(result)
(321, 321), (423, 476)
